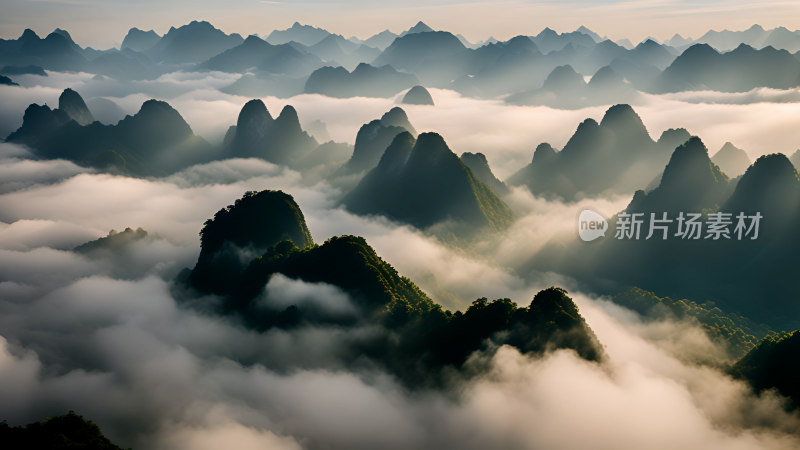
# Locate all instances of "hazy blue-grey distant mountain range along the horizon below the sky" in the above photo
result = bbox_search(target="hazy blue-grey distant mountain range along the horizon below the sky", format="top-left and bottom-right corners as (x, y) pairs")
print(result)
(0, 21), (800, 101)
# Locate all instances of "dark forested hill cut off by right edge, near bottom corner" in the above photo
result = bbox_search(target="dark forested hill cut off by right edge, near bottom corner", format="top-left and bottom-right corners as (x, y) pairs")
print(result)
(731, 330), (800, 409)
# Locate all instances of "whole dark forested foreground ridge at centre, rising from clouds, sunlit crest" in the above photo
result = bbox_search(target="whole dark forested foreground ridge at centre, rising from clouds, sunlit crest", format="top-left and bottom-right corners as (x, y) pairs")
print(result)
(183, 191), (604, 387)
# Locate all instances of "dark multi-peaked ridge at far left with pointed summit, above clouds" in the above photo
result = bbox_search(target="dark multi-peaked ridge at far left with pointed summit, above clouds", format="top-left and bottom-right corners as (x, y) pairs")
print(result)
(6, 89), (216, 176)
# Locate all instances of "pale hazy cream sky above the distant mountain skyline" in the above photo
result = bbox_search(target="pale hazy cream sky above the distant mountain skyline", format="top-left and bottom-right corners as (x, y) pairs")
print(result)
(0, 0), (800, 48)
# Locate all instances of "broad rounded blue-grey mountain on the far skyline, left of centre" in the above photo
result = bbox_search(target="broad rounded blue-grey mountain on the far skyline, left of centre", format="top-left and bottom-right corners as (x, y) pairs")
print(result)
(146, 21), (244, 64)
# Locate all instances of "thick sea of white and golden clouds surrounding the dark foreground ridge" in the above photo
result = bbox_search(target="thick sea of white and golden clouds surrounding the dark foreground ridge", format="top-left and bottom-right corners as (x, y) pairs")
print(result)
(0, 69), (800, 449)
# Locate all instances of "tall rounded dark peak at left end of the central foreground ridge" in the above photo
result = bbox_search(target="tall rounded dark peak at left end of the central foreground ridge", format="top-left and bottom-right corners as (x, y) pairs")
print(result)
(191, 191), (314, 293)
